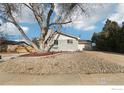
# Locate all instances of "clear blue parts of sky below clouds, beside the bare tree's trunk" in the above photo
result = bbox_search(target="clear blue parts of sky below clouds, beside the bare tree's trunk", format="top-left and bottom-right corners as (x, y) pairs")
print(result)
(11, 22), (104, 40)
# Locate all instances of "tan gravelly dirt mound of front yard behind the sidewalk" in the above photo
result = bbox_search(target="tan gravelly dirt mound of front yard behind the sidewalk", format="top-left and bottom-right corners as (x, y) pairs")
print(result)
(0, 52), (124, 74)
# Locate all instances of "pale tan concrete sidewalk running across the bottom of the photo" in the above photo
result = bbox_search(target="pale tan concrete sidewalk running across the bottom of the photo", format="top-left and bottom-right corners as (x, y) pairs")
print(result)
(0, 72), (124, 85)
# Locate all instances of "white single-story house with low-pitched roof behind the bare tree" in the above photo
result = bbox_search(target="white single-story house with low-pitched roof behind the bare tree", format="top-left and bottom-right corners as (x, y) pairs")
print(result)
(45, 32), (92, 51)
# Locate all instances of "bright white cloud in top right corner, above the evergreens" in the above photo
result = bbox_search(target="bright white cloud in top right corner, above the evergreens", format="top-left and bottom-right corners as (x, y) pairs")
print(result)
(109, 4), (124, 24)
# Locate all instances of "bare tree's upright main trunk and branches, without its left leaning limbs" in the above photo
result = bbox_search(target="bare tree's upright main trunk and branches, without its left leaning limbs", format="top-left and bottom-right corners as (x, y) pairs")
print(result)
(24, 3), (88, 51)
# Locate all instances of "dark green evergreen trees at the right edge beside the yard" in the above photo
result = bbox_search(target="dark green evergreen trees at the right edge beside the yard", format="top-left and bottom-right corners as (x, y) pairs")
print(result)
(92, 19), (124, 52)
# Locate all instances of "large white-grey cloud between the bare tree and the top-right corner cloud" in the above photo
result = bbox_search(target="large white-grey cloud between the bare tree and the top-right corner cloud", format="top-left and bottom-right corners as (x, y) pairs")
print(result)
(68, 4), (114, 31)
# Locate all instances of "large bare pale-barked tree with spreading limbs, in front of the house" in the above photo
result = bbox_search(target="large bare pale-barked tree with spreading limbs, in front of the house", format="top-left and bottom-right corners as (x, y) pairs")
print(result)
(0, 3), (96, 51)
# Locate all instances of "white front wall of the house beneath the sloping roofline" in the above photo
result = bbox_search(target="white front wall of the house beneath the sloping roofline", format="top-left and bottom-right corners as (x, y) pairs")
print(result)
(51, 34), (78, 51)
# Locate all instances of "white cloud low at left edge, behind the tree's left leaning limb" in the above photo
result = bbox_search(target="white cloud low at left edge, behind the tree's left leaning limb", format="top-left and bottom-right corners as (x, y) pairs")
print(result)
(0, 23), (29, 35)
